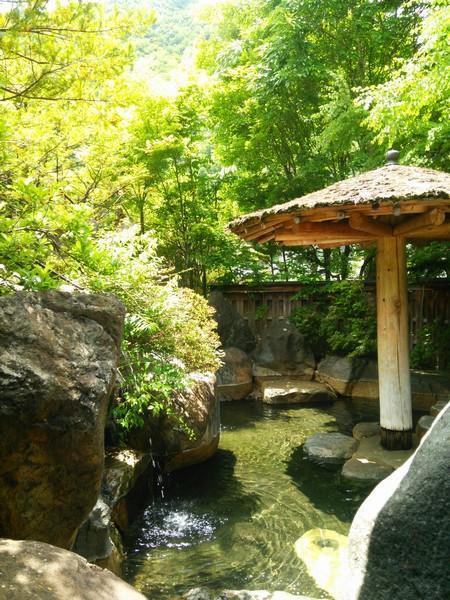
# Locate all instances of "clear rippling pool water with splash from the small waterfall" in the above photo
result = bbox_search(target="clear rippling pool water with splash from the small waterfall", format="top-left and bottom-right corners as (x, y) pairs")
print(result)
(127, 402), (370, 599)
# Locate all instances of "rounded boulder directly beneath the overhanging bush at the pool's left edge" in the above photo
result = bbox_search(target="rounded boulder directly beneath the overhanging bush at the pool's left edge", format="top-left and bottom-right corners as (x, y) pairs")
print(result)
(128, 373), (220, 471)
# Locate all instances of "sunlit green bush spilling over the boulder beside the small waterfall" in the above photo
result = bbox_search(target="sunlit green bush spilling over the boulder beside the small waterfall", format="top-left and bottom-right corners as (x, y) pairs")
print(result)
(86, 229), (220, 435)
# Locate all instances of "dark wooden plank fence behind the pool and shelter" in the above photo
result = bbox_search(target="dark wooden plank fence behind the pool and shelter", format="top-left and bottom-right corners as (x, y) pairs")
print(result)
(214, 280), (450, 349)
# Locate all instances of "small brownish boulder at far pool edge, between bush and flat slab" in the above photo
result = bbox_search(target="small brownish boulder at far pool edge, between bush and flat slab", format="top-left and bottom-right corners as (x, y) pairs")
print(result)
(216, 348), (253, 400)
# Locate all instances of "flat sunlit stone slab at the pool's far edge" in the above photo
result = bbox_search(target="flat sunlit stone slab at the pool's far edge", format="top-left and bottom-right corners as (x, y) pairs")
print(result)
(262, 379), (336, 404)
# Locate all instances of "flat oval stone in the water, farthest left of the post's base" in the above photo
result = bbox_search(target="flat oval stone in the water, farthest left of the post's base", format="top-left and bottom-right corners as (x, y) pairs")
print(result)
(303, 432), (358, 465)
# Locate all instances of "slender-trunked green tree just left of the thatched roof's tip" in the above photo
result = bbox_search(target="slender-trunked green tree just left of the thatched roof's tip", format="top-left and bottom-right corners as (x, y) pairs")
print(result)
(124, 86), (268, 295)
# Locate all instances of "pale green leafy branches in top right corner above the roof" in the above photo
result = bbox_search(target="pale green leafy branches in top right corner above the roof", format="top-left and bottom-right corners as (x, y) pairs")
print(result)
(361, 0), (450, 170)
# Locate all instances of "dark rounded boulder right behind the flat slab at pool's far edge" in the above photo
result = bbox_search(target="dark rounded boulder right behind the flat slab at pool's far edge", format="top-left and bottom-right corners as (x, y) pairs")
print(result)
(252, 319), (316, 379)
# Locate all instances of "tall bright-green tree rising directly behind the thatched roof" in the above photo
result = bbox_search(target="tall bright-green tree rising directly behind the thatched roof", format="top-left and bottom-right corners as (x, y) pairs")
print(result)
(196, 0), (421, 279)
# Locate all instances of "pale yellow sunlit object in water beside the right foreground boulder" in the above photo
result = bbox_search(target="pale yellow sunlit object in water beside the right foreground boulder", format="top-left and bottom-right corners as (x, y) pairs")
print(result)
(295, 529), (348, 598)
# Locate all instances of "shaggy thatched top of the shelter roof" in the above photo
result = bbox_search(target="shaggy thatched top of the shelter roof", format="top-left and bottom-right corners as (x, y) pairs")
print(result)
(229, 165), (450, 232)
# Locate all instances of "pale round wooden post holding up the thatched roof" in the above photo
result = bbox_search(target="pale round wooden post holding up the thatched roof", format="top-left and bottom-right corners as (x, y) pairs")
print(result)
(377, 237), (412, 450)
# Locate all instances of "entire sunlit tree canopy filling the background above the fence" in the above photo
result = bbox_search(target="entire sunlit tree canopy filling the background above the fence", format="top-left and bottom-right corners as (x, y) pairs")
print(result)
(0, 0), (450, 420)
